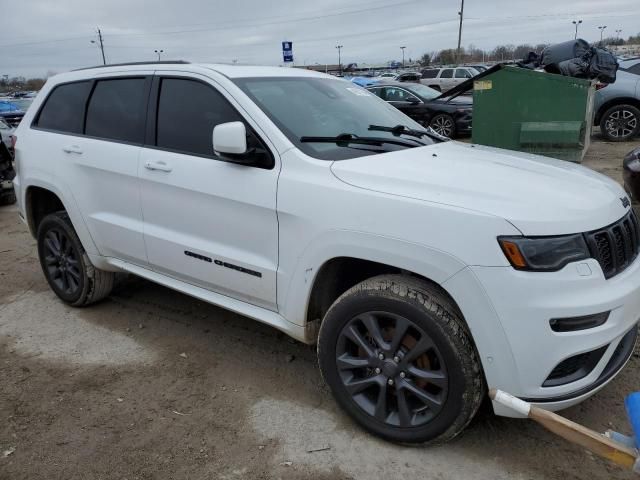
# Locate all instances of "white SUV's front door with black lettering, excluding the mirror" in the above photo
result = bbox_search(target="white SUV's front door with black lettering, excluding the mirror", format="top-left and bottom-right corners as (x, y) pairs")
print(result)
(139, 73), (279, 310)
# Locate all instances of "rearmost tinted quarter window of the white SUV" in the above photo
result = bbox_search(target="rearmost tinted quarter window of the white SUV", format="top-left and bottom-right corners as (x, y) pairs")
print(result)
(36, 82), (91, 134)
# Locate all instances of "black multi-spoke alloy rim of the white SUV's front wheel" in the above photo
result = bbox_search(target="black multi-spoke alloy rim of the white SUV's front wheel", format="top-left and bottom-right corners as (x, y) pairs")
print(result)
(336, 311), (449, 428)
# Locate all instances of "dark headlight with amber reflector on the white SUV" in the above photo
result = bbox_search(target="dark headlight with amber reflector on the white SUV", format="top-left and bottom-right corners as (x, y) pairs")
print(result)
(498, 234), (591, 272)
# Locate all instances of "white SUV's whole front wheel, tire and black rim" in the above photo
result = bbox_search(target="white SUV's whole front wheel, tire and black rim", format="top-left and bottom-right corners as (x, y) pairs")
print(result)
(318, 275), (486, 443)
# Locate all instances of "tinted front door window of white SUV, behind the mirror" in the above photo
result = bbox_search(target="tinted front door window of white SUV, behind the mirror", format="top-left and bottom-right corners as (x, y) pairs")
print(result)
(156, 78), (242, 157)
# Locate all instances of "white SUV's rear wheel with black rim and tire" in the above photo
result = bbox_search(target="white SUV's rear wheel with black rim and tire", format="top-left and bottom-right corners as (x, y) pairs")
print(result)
(38, 212), (115, 307)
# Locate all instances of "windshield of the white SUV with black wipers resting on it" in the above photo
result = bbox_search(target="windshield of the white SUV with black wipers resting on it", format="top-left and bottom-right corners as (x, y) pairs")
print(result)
(235, 77), (433, 160)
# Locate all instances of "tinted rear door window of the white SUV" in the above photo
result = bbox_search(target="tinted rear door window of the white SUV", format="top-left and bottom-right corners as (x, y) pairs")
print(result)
(85, 78), (146, 143)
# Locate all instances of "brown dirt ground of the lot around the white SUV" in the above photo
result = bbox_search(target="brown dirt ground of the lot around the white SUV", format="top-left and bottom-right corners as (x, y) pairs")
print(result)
(0, 138), (640, 480)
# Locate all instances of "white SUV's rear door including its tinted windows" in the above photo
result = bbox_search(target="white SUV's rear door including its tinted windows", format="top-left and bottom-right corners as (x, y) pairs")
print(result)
(35, 74), (151, 265)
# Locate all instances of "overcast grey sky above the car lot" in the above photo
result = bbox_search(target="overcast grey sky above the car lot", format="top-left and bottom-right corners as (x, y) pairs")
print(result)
(0, 0), (640, 77)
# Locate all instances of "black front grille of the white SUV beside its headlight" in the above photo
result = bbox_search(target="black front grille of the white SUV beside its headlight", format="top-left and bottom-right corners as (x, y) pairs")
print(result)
(585, 210), (640, 278)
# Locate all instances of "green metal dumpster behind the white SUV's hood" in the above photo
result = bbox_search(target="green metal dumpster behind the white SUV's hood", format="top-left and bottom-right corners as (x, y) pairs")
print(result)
(472, 66), (595, 162)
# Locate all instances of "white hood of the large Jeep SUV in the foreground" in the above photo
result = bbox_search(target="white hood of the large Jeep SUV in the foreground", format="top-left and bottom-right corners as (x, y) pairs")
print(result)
(331, 142), (628, 235)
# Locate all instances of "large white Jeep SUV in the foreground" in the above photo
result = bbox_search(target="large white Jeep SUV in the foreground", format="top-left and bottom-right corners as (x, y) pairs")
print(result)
(15, 63), (640, 442)
